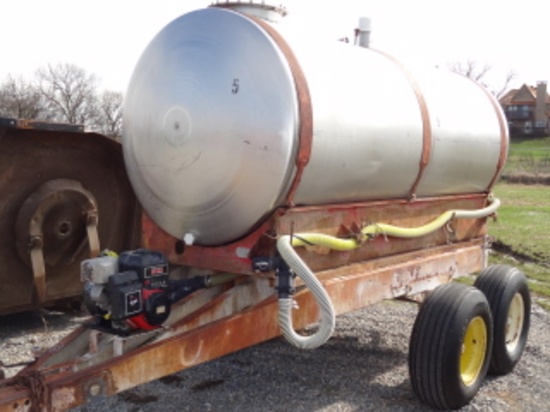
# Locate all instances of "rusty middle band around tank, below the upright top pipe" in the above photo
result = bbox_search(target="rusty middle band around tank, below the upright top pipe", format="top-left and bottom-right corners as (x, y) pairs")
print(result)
(370, 49), (432, 199)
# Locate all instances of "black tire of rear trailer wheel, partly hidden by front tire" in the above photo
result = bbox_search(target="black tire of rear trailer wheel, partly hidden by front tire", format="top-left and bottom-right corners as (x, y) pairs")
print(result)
(474, 265), (531, 375)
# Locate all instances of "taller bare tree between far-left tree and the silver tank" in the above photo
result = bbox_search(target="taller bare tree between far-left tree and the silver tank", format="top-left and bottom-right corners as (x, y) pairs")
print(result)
(36, 63), (97, 124)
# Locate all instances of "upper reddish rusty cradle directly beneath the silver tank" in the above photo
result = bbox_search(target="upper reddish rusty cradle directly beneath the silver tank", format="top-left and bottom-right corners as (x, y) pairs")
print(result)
(141, 193), (487, 275)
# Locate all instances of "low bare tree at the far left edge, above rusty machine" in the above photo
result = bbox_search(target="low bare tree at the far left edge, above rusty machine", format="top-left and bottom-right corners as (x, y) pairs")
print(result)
(0, 76), (47, 120)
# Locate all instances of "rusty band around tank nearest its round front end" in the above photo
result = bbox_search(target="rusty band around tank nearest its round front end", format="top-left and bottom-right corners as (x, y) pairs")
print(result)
(246, 15), (313, 206)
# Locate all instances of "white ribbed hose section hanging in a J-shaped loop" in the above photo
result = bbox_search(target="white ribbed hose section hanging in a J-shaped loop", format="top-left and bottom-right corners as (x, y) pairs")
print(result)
(277, 235), (336, 349)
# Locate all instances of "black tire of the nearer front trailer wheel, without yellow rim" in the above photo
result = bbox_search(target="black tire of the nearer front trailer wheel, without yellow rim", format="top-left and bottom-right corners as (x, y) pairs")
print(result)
(409, 283), (493, 409)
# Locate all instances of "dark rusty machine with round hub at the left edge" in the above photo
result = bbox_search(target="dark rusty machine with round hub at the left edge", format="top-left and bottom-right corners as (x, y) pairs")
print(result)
(0, 126), (141, 315)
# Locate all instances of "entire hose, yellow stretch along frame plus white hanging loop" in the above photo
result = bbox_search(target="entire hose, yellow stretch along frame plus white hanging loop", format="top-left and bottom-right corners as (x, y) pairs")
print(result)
(277, 196), (500, 349)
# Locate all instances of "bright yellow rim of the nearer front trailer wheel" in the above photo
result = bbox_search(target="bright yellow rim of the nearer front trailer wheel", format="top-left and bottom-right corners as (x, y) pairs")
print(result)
(460, 316), (487, 386)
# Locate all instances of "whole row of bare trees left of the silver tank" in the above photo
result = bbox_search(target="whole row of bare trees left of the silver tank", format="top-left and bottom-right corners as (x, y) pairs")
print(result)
(0, 63), (123, 139)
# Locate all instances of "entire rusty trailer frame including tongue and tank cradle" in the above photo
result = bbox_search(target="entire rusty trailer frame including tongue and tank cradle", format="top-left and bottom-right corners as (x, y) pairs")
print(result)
(0, 194), (489, 412)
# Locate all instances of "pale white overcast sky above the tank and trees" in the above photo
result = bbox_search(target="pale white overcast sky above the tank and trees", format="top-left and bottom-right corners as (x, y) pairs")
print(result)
(0, 0), (550, 92)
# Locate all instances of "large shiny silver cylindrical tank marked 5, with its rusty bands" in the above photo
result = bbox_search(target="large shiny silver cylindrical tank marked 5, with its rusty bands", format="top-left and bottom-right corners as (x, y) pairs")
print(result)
(123, 8), (508, 245)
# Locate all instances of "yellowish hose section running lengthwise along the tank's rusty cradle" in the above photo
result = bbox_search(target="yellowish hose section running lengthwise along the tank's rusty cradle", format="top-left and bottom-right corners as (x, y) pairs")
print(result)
(292, 196), (500, 251)
